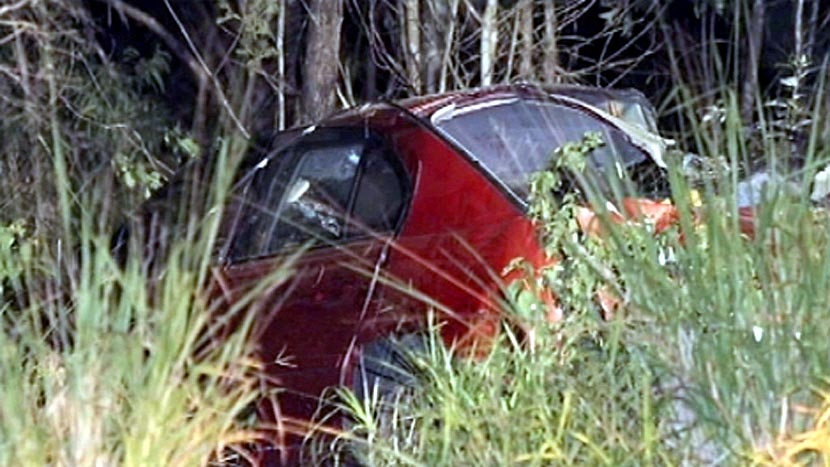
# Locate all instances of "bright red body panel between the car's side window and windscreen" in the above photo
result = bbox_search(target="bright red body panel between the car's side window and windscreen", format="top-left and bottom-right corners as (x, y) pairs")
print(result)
(378, 120), (543, 352)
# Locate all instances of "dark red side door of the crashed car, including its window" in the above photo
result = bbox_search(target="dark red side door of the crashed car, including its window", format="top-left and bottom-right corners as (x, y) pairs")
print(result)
(214, 128), (409, 426)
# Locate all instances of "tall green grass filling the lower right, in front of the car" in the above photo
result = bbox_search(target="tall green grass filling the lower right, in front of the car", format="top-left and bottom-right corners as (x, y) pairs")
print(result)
(334, 88), (830, 465)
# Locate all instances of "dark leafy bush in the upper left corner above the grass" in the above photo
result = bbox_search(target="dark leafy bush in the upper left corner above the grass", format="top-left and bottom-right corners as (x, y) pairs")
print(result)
(0, 2), (178, 218)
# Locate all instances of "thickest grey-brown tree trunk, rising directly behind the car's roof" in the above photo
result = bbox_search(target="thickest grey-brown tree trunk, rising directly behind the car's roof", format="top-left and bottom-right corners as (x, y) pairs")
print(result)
(303, 0), (343, 121)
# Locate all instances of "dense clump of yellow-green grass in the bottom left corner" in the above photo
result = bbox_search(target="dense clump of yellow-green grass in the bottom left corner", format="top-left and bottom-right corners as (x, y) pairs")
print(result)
(0, 242), (257, 465)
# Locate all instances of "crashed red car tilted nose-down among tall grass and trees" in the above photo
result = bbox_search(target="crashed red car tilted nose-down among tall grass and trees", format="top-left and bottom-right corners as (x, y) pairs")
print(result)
(128, 85), (676, 464)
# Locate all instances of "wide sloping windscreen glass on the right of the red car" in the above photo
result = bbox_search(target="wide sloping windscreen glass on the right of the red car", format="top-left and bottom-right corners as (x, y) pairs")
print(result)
(432, 98), (649, 199)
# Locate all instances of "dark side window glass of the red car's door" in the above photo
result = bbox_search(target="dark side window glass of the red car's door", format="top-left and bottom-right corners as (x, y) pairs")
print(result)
(230, 129), (406, 261)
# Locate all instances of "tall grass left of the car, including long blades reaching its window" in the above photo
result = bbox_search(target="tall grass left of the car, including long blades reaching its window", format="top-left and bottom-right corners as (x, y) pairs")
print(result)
(0, 140), (289, 466)
